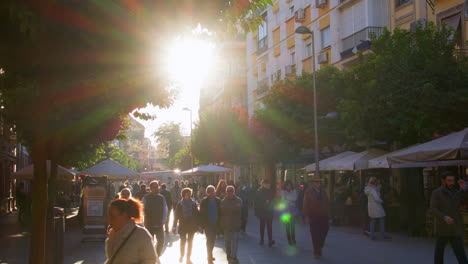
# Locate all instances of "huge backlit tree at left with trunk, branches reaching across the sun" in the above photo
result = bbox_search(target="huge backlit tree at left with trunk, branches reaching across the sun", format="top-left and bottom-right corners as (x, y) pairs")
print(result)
(0, 0), (267, 264)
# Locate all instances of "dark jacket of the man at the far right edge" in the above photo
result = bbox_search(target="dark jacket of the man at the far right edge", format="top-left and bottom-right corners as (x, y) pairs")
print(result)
(431, 186), (468, 237)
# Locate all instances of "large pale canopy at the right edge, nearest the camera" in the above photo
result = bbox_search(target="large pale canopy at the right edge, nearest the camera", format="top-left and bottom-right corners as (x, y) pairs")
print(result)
(387, 128), (468, 168)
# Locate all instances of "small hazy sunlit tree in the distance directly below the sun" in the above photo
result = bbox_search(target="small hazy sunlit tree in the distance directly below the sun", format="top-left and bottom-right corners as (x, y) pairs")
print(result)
(153, 122), (184, 167)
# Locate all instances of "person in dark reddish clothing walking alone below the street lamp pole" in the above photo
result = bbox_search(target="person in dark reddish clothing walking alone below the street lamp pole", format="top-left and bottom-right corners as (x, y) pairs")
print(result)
(303, 175), (329, 259)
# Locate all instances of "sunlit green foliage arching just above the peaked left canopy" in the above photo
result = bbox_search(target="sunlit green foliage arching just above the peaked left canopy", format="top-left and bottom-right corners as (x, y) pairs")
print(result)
(71, 142), (141, 171)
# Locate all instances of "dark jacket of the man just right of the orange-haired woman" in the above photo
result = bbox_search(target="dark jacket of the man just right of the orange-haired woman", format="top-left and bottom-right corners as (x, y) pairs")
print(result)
(143, 193), (167, 227)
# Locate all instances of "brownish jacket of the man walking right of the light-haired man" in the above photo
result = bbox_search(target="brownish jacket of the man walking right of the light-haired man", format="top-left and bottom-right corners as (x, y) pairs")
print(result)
(221, 196), (242, 232)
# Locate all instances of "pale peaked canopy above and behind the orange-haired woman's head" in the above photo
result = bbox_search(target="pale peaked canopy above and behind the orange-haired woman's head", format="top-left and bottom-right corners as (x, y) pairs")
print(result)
(81, 159), (139, 180)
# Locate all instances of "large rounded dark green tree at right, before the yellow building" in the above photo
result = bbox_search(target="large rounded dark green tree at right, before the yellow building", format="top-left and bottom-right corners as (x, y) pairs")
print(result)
(339, 23), (468, 145)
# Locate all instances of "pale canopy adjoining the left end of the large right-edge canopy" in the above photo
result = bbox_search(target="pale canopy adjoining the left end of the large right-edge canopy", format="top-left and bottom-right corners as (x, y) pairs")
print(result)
(328, 149), (386, 170)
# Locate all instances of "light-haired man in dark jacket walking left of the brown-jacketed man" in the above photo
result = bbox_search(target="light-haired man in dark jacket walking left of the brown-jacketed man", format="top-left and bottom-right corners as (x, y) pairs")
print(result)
(200, 185), (221, 264)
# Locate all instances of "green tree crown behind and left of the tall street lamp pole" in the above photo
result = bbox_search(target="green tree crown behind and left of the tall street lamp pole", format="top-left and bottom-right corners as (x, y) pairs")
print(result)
(255, 66), (344, 154)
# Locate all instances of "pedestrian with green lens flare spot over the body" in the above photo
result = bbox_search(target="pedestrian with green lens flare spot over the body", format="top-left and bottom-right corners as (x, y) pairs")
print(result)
(281, 180), (300, 246)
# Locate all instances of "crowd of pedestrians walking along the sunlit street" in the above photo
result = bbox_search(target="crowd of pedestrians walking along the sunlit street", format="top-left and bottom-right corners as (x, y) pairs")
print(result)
(106, 171), (466, 264)
